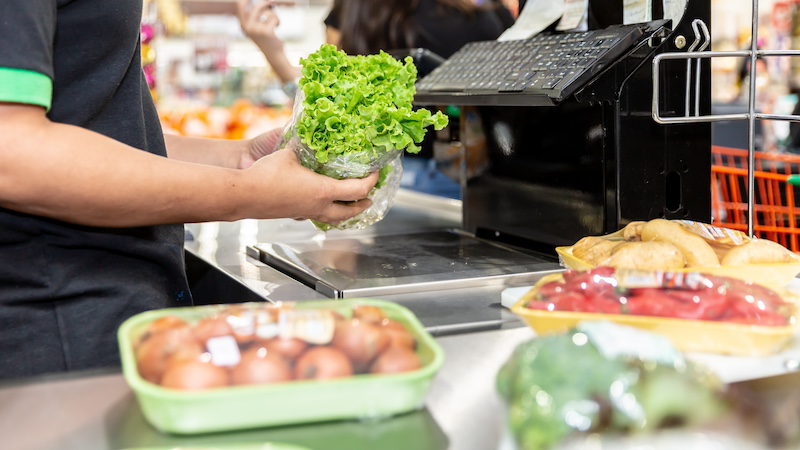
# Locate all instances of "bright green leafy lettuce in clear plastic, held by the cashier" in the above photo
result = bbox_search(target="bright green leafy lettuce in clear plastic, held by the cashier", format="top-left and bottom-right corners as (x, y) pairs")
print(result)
(284, 44), (447, 230)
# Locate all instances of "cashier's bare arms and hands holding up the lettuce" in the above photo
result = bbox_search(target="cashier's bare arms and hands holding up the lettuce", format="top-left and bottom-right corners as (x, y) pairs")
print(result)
(0, 103), (378, 227)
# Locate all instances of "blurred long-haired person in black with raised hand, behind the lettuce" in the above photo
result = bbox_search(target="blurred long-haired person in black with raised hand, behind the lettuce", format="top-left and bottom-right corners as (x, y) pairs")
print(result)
(238, 0), (514, 83)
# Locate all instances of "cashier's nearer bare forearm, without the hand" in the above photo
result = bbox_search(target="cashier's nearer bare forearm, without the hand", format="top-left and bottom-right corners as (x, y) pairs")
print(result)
(0, 107), (255, 227)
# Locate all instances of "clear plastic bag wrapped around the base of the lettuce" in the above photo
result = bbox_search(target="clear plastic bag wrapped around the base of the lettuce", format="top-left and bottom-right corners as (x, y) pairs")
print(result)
(281, 91), (403, 231)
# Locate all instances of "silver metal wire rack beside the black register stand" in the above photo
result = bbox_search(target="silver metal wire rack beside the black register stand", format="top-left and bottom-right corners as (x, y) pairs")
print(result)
(652, 0), (800, 237)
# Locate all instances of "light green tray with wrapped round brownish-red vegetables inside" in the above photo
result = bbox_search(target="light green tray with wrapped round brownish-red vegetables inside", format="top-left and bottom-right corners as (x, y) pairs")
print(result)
(118, 299), (444, 434)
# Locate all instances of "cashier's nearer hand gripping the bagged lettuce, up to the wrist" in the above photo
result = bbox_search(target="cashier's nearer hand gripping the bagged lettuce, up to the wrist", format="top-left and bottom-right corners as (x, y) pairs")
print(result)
(245, 147), (378, 225)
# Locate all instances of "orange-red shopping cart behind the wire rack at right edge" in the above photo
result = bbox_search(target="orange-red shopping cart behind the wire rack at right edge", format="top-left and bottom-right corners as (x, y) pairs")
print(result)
(711, 146), (800, 252)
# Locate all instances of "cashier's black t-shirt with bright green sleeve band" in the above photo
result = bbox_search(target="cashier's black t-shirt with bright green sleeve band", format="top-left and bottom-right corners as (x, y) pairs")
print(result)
(0, 0), (191, 378)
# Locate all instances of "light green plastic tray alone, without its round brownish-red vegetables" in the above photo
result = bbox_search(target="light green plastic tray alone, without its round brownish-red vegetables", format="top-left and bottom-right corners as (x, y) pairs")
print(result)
(118, 299), (444, 434)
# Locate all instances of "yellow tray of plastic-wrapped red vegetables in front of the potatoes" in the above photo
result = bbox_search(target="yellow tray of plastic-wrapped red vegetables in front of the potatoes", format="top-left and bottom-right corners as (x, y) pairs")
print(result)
(511, 267), (797, 356)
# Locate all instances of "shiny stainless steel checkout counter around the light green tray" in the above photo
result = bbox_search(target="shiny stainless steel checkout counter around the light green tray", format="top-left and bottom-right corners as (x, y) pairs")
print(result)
(0, 191), (800, 450)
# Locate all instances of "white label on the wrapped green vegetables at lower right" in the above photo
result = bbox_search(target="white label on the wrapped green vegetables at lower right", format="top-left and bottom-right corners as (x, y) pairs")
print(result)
(576, 322), (686, 367)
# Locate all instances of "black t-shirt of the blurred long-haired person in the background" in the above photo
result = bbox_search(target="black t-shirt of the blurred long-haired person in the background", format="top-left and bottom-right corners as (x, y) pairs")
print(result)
(325, 0), (513, 58)
